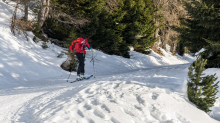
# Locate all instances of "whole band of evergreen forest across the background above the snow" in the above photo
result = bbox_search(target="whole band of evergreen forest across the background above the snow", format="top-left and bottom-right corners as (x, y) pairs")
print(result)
(11, 0), (220, 68)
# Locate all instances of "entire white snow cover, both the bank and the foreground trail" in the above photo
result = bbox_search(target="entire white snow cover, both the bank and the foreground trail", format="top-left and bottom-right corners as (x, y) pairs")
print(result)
(0, 0), (220, 123)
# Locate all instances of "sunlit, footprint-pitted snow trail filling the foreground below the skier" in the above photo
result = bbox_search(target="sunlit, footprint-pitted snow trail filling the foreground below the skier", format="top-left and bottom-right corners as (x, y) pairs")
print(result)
(0, 65), (218, 123)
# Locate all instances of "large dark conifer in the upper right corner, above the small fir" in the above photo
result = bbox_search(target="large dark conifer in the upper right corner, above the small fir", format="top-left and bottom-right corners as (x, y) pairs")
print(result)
(177, 0), (220, 68)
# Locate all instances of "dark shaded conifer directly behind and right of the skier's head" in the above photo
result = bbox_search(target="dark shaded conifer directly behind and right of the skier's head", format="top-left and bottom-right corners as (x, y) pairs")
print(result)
(82, 4), (130, 58)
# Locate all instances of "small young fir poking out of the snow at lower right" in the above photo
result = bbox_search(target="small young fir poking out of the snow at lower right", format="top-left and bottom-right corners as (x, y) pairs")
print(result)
(187, 57), (219, 112)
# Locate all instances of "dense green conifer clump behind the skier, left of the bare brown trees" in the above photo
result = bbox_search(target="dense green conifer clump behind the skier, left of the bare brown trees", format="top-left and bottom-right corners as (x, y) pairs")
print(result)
(44, 0), (160, 58)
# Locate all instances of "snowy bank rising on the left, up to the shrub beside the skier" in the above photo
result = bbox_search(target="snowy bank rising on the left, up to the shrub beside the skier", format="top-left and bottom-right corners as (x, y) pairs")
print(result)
(0, 0), (63, 88)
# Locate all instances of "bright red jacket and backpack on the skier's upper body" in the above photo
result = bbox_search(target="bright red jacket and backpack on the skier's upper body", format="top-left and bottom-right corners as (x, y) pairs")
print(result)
(70, 37), (89, 54)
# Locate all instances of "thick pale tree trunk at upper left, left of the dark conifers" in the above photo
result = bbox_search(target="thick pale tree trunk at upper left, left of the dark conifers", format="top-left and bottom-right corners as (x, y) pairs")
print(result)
(38, 0), (50, 27)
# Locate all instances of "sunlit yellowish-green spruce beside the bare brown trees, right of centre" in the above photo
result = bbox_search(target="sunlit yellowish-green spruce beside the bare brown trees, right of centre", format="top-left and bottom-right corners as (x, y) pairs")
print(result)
(122, 0), (160, 52)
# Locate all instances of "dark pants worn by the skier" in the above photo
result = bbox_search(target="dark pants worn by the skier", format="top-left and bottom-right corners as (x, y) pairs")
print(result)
(76, 53), (85, 75)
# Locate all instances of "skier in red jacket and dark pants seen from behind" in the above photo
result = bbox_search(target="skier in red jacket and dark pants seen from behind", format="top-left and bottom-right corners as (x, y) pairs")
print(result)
(70, 35), (92, 80)
